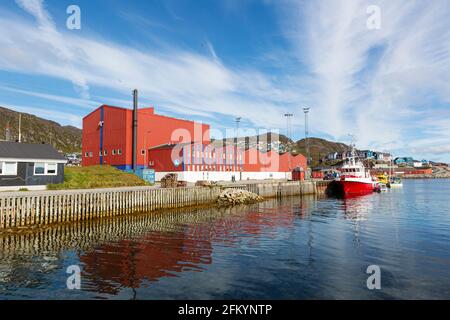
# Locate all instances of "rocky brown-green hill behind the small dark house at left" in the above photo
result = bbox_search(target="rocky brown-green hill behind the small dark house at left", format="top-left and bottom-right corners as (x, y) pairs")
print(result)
(0, 107), (81, 152)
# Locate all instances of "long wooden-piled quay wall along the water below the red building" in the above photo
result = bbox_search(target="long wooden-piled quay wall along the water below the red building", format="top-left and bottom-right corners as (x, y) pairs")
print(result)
(0, 181), (328, 231)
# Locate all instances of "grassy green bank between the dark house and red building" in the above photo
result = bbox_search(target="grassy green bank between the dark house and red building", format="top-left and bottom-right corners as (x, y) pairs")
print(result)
(47, 166), (149, 190)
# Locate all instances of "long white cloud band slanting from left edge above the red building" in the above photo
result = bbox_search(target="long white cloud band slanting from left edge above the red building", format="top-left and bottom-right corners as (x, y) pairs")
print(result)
(0, 2), (300, 128)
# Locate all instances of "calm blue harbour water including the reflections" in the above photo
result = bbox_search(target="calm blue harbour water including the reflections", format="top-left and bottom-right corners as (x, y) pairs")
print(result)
(0, 180), (450, 299)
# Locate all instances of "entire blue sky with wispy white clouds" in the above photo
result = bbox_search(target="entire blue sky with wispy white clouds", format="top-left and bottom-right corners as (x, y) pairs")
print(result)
(0, 0), (450, 162)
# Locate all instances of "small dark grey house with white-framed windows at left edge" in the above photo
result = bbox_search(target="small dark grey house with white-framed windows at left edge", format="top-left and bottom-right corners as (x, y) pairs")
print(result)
(0, 141), (67, 191)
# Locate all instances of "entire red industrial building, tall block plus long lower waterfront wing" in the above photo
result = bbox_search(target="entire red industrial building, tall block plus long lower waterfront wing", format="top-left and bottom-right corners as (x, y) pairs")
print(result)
(82, 105), (306, 182)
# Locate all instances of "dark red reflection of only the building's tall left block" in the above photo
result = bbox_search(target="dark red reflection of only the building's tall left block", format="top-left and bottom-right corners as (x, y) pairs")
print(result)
(80, 233), (212, 294)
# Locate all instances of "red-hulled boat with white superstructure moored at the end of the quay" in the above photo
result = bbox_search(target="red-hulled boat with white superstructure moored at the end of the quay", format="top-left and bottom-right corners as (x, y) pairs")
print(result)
(335, 146), (374, 196)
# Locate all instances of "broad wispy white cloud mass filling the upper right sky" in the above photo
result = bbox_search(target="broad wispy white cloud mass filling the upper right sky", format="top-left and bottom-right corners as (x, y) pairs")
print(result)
(284, 0), (450, 159)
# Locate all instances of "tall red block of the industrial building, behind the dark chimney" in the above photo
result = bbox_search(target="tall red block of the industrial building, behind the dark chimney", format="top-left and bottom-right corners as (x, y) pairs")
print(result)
(82, 105), (210, 169)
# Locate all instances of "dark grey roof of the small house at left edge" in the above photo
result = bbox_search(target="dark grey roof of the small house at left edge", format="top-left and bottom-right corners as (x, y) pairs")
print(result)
(0, 141), (65, 161)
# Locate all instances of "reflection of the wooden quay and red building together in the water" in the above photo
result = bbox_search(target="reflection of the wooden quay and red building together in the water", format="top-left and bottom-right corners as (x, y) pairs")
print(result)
(0, 197), (315, 295)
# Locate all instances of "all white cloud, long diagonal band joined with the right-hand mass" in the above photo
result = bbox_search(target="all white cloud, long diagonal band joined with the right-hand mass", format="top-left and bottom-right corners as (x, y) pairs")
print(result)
(0, 0), (450, 161)
